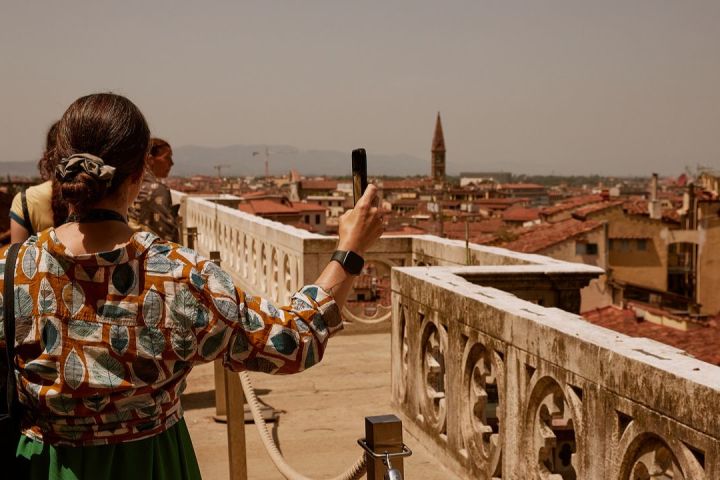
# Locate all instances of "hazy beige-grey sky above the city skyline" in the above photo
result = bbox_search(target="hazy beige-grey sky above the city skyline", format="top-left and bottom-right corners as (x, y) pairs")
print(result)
(0, 0), (720, 174)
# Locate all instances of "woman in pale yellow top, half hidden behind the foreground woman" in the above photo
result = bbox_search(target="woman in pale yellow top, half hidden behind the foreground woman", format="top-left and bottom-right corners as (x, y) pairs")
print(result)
(10, 122), (68, 243)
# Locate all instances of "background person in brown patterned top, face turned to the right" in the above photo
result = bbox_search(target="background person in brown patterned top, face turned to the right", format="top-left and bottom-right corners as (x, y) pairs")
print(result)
(128, 138), (180, 242)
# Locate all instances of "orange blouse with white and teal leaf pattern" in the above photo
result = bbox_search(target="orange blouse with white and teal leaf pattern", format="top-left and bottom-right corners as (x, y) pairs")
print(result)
(0, 229), (342, 445)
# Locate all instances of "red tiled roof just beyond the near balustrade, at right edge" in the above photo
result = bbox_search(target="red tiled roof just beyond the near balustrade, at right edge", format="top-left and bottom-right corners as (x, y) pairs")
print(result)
(583, 306), (720, 365)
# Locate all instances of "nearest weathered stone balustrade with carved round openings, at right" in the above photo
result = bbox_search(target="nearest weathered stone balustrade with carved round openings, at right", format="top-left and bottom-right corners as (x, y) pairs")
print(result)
(392, 264), (720, 480)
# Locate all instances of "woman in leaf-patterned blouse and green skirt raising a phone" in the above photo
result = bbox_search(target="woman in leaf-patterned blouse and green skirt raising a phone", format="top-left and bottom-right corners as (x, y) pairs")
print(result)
(0, 94), (382, 480)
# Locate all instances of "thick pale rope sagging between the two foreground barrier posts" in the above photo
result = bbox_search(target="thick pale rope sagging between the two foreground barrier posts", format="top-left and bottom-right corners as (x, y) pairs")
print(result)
(240, 372), (366, 480)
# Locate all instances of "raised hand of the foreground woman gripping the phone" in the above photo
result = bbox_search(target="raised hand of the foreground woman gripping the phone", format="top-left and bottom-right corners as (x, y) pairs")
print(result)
(338, 184), (384, 255)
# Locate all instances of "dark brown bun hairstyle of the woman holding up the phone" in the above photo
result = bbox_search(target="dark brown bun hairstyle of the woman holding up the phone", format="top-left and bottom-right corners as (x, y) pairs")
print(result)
(55, 93), (150, 213)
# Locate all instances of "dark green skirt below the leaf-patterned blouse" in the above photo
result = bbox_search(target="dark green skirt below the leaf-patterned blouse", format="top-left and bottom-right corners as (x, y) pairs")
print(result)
(17, 419), (201, 480)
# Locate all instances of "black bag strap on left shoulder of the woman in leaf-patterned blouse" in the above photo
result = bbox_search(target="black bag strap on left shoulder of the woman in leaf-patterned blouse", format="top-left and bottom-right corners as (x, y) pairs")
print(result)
(3, 243), (22, 416)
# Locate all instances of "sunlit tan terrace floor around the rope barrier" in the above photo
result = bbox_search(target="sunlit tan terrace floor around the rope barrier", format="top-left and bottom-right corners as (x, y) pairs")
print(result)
(183, 333), (458, 480)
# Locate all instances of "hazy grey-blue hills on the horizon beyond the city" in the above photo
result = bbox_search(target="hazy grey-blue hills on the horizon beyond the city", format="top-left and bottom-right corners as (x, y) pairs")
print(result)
(0, 145), (430, 177)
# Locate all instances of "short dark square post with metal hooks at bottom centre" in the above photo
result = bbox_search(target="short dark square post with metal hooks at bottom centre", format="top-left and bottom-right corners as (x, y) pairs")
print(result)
(365, 415), (405, 480)
